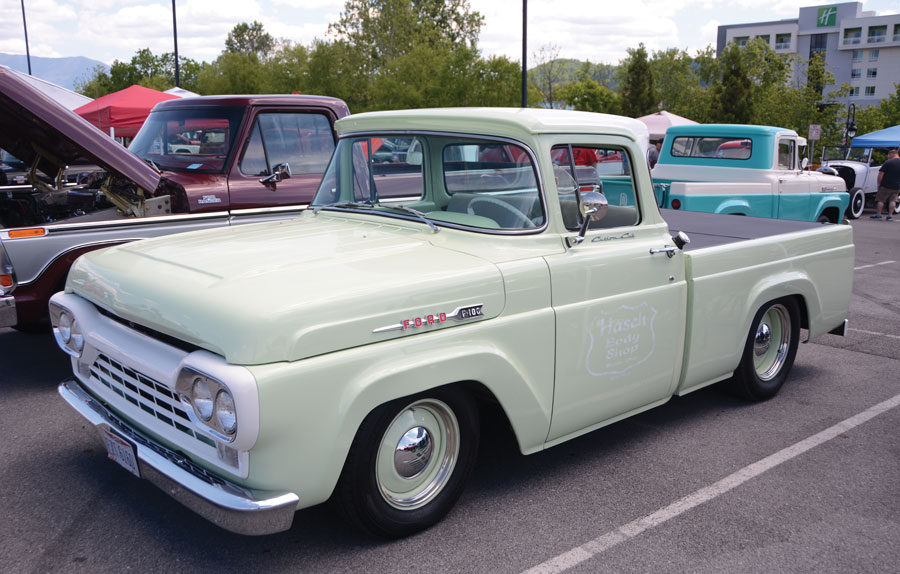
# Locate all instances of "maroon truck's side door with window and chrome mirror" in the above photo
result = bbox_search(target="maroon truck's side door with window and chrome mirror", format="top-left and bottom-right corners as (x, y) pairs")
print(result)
(228, 108), (334, 210)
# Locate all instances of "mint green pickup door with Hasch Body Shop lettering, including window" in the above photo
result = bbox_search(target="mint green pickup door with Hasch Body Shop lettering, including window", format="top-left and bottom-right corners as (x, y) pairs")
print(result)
(547, 144), (687, 441)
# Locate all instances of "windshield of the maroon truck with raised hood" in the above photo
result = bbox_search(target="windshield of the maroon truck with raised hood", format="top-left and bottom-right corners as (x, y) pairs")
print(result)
(128, 107), (244, 173)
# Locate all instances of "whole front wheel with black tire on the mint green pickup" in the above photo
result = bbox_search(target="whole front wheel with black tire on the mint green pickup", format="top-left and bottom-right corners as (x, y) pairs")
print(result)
(335, 387), (479, 538)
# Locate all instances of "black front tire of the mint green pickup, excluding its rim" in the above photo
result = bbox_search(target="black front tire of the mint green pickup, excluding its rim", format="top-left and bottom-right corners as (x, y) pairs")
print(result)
(337, 387), (479, 538)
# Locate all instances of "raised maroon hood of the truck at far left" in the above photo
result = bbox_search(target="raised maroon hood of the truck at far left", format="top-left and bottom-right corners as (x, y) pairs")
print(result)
(0, 66), (160, 193)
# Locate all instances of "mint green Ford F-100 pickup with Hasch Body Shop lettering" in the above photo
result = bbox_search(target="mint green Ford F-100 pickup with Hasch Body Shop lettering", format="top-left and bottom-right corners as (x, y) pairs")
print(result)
(50, 109), (854, 537)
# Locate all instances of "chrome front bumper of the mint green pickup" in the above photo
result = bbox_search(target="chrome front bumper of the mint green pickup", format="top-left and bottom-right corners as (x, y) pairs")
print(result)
(59, 379), (300, 535)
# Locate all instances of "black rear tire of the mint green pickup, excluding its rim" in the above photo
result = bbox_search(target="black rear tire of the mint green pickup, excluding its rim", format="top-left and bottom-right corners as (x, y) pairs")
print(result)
(734, 297), (800, 401)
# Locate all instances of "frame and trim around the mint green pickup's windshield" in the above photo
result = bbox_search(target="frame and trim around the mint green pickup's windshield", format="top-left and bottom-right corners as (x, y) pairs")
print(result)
(309, 130), (550, 236)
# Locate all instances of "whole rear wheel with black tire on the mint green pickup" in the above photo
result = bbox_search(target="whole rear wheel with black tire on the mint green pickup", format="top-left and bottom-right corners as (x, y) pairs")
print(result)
(732, 297), (800, 401)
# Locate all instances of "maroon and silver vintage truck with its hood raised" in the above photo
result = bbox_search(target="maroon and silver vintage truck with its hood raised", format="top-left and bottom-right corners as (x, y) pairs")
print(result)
(0, 67), (349, 330)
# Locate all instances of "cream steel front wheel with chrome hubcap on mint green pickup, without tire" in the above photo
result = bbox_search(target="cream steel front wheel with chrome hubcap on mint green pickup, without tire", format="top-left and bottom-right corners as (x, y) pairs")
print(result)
(375, 399), (459, 510)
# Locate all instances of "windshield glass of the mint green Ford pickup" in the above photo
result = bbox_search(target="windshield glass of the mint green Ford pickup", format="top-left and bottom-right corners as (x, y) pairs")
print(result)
(312, 134), (545, 231)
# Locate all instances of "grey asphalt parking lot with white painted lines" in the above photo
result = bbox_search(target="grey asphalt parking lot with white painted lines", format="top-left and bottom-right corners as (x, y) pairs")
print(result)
(0, 212), (900, 573)
